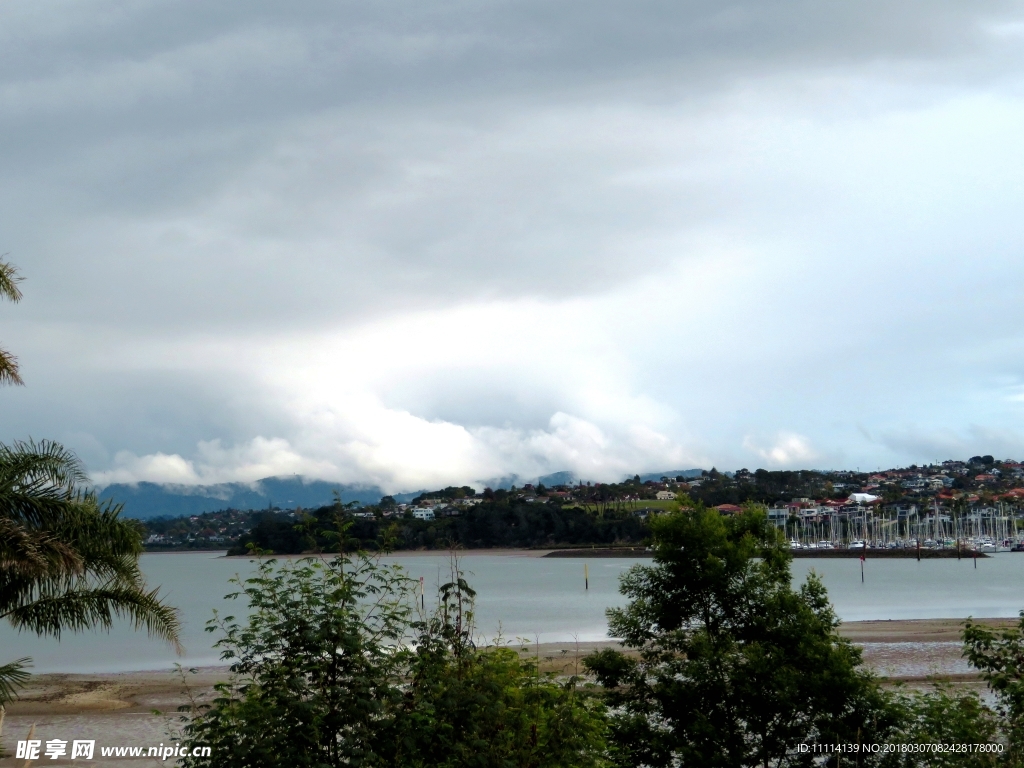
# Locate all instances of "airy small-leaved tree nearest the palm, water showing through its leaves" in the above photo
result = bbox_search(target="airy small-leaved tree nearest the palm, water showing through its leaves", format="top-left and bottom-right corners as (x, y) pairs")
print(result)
(182, 556), (412, 768)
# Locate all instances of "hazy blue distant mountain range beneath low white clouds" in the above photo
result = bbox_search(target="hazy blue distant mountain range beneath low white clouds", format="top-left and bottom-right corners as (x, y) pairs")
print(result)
(99, 469), (700, 520)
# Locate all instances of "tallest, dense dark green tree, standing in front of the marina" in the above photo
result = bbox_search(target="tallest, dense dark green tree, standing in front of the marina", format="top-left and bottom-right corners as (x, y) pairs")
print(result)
(585, 505), (897, 768)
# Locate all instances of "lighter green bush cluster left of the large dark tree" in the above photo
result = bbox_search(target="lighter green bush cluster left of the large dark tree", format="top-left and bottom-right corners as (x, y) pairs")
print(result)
(182, 555), (604, 768)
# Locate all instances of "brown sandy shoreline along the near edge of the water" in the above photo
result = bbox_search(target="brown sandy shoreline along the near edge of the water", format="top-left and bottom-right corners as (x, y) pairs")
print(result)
(7, 618), (1019, 722)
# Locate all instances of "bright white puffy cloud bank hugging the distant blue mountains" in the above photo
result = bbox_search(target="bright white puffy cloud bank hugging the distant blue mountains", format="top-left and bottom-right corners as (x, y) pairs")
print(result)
(93, 407), (696, 492)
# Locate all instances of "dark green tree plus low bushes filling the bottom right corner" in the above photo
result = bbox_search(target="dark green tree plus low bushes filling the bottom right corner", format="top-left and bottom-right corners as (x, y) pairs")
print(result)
(585, 505), (1024, 768)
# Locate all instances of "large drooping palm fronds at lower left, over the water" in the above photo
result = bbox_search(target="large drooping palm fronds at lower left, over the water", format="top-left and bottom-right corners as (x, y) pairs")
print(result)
(0, 441), (181, 708)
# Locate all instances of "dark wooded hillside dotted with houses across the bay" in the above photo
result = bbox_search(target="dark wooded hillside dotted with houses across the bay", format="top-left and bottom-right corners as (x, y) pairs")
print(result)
(138, 456), (1024, 553)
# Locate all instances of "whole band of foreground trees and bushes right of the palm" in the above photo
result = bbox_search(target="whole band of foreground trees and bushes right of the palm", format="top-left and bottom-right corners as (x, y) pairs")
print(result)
(183, 507), (1024, 768)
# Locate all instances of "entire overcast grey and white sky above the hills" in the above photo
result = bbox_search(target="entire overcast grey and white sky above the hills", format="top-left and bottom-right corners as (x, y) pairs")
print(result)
(0, 0), (1024, 490)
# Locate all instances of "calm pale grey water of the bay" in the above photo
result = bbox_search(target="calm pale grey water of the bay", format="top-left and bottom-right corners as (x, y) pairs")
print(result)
(0, 553), (1024, 673)
